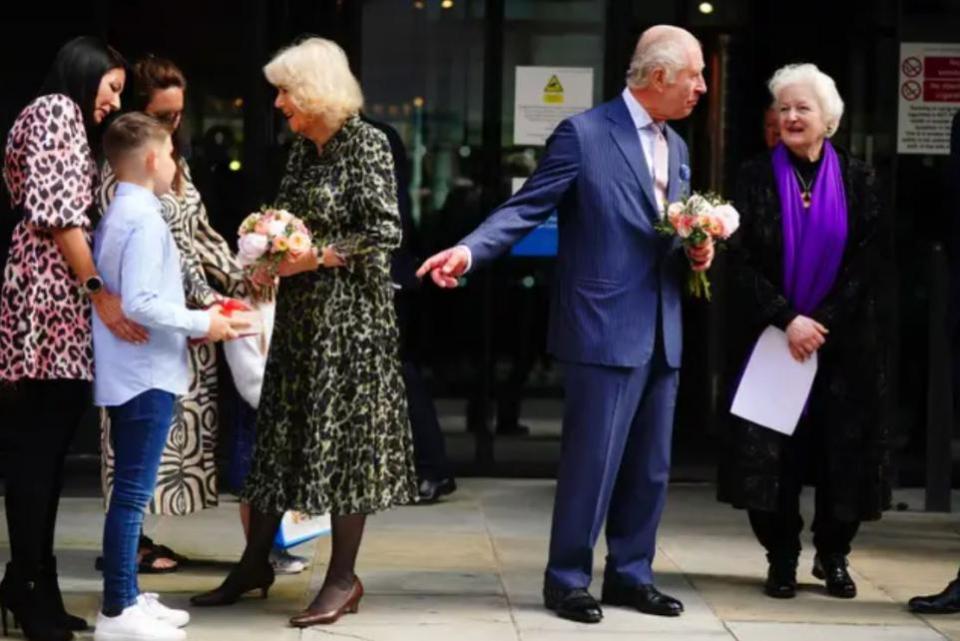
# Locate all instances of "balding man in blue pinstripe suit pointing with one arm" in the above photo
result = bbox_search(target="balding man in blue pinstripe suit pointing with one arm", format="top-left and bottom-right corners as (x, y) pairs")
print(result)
(418, 25), (713, 623)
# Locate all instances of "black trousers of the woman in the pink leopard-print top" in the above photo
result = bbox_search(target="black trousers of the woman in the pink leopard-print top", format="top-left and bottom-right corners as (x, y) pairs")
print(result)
(2, 379), (91, 576)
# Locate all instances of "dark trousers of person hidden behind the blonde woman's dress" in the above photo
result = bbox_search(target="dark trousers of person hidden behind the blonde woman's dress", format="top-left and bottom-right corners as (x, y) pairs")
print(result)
(394, 291), (453, 481)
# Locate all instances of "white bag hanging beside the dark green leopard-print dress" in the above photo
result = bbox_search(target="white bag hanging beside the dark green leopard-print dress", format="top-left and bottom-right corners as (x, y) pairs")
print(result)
(223, 300), (276, 409)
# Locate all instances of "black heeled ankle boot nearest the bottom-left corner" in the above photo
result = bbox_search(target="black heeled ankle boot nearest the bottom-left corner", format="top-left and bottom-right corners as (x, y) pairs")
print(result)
(0, 564), (73, 641)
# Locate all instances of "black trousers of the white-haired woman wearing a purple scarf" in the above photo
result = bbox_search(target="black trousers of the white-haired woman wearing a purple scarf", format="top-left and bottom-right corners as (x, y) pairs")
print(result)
(749, 418), (860, 561)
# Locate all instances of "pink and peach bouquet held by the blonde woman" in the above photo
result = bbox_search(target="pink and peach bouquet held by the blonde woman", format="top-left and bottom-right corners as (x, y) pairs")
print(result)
(237, 208), (313, 300)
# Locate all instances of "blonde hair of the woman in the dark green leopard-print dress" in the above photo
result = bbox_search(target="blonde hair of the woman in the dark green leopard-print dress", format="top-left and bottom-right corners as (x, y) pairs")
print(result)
(263, 38), (363, 128)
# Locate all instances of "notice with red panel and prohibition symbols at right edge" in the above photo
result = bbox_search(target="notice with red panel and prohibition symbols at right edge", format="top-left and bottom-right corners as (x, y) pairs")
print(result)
(897, 42), (960, 155)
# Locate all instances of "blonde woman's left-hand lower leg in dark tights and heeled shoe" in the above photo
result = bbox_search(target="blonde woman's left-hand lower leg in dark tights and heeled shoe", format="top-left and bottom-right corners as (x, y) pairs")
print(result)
(190, 510), (281, 607)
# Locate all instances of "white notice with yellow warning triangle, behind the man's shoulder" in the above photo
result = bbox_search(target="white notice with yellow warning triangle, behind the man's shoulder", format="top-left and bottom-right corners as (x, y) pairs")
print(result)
(513, 67), (593, 145)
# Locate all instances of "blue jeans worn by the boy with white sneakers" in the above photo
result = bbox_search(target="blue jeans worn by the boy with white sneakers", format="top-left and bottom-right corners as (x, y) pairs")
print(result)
(103, 389), (175, 616)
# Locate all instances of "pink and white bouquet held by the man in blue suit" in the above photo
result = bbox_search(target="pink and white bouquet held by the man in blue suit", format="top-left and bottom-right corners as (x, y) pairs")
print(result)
(657, 193), (740, 300)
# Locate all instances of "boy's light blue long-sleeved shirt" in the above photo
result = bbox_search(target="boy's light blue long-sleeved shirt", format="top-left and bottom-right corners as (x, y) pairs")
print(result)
(93, 182), (210, 407)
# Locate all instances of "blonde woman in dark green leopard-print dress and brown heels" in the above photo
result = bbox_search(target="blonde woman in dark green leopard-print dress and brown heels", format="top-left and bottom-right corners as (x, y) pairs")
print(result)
(193, 38), (417, 627)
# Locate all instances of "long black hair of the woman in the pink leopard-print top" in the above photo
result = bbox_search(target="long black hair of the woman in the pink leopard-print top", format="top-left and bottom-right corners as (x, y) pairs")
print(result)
(39, 36), (127, 135)
